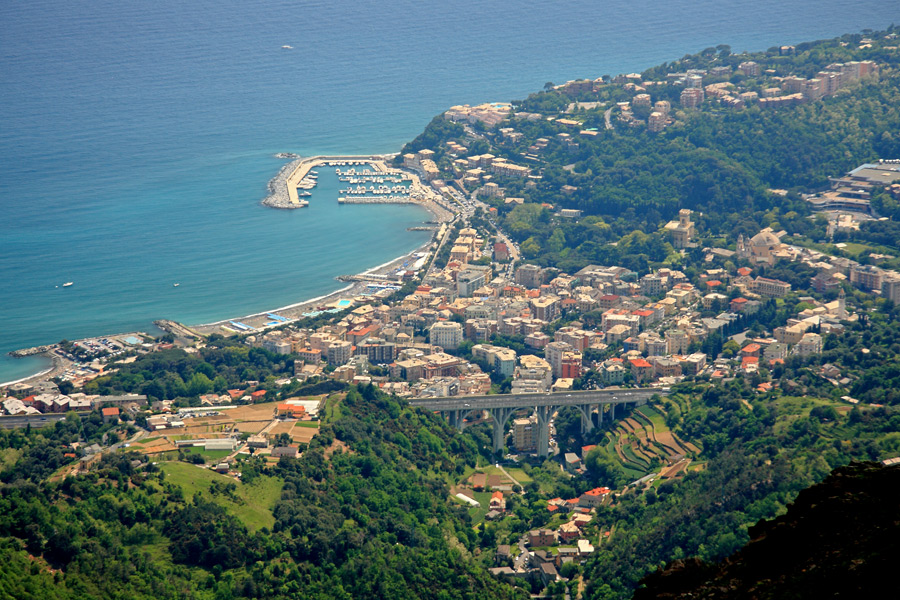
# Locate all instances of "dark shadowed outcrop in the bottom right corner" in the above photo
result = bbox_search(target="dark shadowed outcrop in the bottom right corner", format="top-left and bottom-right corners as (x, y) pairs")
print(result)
(634, 463), (900, 600)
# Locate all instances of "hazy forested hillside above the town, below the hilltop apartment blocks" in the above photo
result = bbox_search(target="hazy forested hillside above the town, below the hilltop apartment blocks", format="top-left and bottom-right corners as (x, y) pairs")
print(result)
(403, 28), (900, 270)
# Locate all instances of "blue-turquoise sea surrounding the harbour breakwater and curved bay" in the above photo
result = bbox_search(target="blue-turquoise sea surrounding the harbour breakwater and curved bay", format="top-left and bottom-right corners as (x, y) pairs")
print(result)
(0, 0), (900, 382)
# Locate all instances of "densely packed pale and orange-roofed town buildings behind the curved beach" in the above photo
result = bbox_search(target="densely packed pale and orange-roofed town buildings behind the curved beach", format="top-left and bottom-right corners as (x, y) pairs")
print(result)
(2, 125), (900, 585)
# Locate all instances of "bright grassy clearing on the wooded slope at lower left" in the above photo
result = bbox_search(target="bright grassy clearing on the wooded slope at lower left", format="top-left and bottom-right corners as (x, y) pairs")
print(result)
(160, 462), (284, 531)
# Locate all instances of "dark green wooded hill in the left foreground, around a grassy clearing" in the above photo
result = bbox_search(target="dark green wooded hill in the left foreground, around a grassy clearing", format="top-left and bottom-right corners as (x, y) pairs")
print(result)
(0, 386), (520, 600)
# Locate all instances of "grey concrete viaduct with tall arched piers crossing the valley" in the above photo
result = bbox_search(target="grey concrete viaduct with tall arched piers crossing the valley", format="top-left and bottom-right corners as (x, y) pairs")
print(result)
(409, 388), (669, 456)
